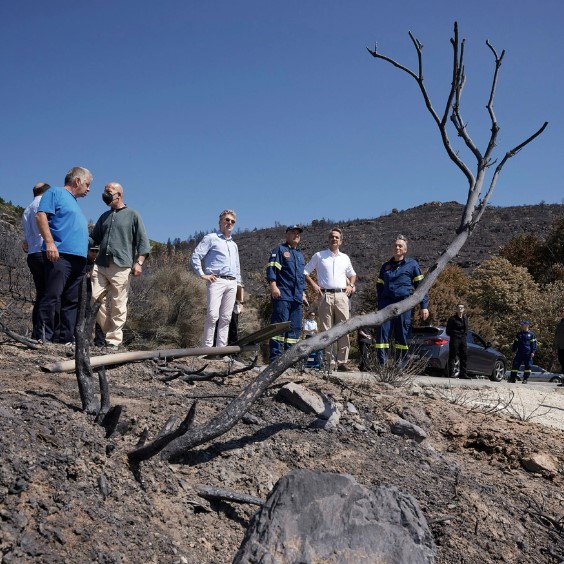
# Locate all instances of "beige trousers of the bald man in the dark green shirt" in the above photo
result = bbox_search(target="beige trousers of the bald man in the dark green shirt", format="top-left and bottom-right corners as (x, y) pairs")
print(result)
(92, 261), (131, 345)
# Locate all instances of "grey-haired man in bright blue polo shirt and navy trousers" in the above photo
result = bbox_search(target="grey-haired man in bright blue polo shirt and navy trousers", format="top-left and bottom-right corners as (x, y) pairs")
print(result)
(36, 167), (92, 343)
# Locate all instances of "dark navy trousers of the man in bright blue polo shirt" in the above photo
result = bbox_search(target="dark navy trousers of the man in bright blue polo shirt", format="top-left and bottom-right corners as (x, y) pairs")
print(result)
(37, 253), (86, 343)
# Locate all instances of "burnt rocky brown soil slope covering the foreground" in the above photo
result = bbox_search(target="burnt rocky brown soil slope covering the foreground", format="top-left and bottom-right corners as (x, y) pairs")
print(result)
(0, 341), (564, 564)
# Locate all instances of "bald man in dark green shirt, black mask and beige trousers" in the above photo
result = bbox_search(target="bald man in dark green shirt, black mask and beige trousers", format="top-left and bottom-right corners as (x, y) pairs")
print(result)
(90, 182), (151, 350)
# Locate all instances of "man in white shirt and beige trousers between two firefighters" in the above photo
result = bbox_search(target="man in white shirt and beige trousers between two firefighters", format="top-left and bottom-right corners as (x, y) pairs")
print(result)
(304, 227), (356, 372)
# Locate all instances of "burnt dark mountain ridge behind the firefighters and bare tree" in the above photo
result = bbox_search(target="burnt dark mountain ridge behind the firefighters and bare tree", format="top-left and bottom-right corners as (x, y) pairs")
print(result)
(231, 202), (564, 292)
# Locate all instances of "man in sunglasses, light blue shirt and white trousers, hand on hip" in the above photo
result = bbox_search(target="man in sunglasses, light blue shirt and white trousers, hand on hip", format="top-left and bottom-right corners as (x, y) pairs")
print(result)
(191, 210), (243, 347)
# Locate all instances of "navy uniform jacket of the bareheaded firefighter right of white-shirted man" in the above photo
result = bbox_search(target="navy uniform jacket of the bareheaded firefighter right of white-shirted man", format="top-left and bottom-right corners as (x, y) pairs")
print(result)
(376, 257), (429, 309)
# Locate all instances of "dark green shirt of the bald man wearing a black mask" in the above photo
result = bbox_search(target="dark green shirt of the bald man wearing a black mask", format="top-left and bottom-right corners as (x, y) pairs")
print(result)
(90, 206), (151, 268)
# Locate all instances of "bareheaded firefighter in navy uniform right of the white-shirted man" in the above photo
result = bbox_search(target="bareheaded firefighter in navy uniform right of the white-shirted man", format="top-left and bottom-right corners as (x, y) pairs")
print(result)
(374, 235), (429, 364)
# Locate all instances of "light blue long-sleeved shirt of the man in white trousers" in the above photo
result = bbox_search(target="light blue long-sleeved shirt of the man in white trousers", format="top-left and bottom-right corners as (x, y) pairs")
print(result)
(190, 231), (241, 284)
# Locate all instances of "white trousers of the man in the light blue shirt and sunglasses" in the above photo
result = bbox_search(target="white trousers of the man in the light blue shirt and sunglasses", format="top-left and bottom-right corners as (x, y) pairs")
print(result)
(202, 278), (237, 347)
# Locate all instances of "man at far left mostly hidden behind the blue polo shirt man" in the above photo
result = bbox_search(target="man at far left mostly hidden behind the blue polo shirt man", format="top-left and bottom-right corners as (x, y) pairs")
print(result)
(22, 182), (51, 339)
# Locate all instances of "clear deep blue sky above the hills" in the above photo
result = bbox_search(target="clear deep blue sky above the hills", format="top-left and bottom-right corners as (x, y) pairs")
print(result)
(0, 0), (564, 241)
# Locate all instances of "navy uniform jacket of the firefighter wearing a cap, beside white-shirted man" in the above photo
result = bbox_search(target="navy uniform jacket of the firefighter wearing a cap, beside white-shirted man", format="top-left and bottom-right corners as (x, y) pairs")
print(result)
(266, 243), (305, 303)
